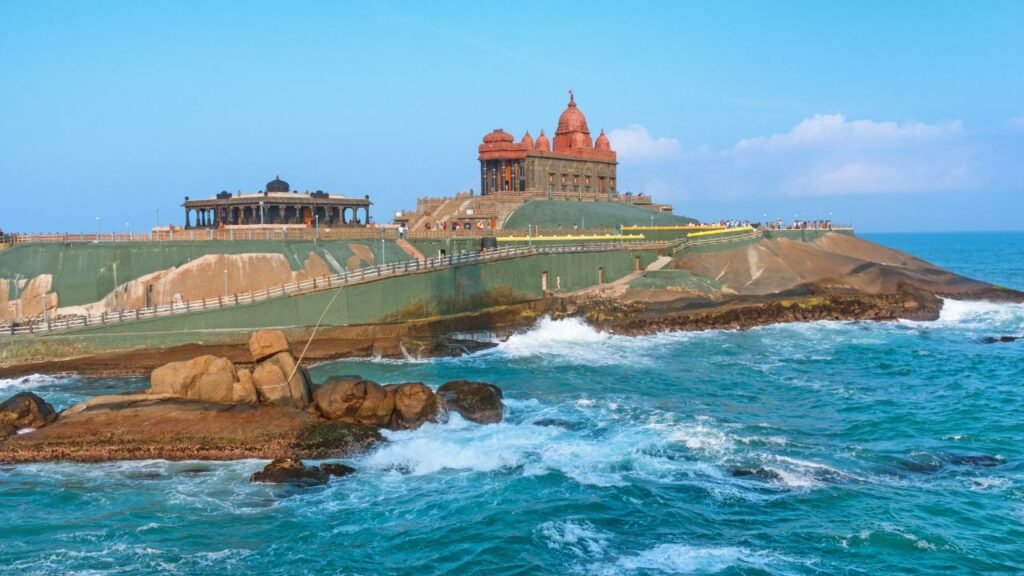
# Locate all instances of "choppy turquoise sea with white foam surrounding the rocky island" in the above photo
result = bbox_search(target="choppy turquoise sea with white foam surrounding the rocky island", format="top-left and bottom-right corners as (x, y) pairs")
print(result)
(0, 234), (1024, 575)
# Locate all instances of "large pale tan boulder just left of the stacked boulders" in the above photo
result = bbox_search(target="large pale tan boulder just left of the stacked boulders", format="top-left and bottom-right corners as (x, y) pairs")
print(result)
(147, 355), (238, 402)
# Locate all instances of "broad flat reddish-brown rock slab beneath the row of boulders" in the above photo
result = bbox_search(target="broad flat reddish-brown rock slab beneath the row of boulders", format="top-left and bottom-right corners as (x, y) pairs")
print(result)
(0, 395), (383, 462)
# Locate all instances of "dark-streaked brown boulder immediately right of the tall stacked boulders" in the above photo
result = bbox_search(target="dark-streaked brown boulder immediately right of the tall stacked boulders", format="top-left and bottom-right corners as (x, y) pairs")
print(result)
(313, 376), (394, 426)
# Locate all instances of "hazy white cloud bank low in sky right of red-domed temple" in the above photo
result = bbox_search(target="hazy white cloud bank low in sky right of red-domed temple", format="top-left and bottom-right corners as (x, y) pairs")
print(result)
(613, 114), (1007, 201)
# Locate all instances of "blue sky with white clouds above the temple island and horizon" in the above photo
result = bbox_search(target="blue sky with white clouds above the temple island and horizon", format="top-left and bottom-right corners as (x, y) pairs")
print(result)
(0, 0), (1024, 232)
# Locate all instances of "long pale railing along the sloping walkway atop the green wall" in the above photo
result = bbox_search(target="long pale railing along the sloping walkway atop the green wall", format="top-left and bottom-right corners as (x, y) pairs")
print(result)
(0, 241), (668, 336)
